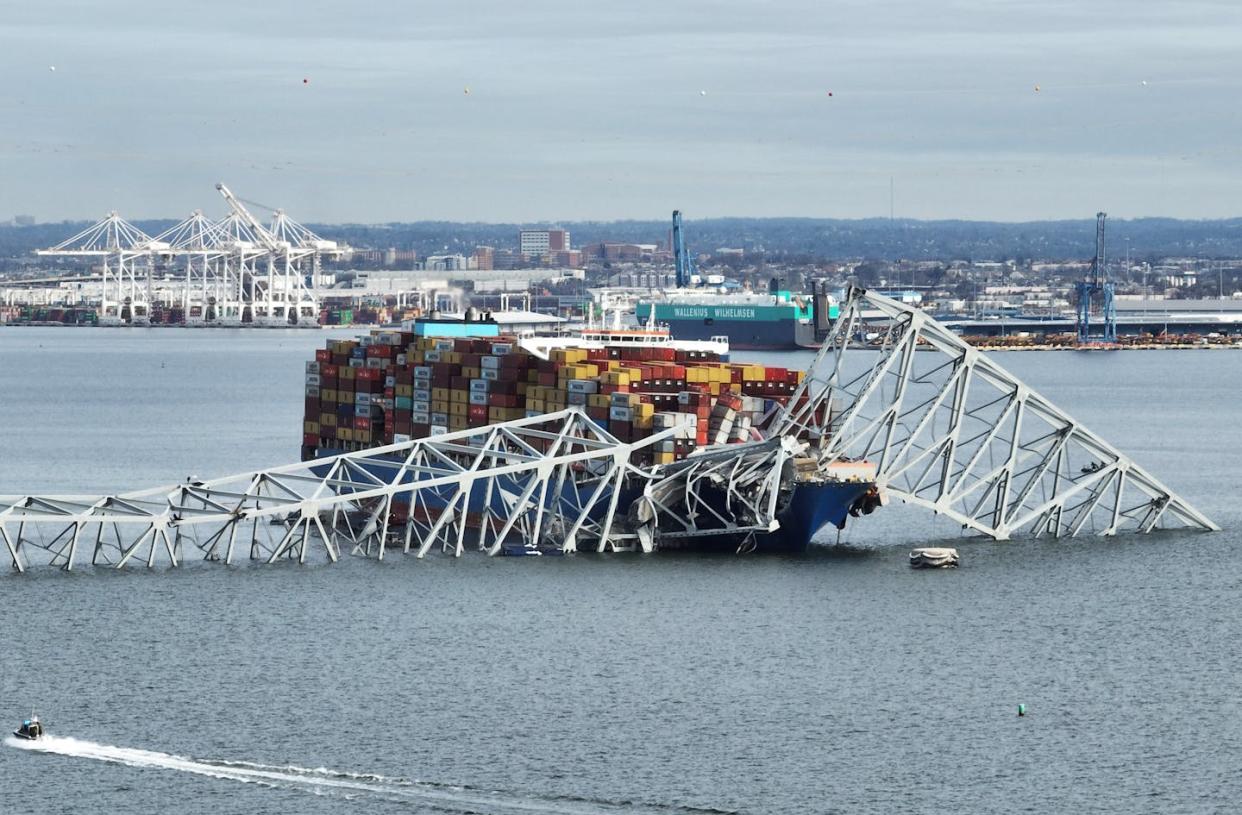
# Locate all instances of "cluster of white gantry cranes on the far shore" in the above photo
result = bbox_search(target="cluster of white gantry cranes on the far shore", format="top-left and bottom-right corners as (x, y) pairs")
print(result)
(36, 184), (350, 328)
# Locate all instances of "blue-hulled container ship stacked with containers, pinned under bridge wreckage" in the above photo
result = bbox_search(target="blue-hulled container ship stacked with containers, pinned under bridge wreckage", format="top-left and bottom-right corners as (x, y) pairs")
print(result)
(302, 315), (879, 554)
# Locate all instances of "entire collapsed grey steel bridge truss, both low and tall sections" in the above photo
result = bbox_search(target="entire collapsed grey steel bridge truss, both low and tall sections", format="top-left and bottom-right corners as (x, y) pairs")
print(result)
(0, 288), (1217, 570)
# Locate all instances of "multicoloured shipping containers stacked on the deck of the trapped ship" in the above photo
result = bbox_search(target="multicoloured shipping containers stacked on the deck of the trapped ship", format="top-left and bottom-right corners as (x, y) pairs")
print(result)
(302, 330), (802, 463)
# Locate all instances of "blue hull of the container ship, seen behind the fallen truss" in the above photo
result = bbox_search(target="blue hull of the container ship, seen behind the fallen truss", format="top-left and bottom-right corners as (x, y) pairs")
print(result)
(312, 447), (876, 555)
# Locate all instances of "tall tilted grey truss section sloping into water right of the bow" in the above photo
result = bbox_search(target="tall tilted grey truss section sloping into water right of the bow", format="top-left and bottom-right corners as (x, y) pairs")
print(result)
(777, 288), (1218, 539)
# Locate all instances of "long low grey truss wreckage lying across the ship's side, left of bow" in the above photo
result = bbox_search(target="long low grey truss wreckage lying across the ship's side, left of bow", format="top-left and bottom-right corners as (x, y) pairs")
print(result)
(0, 408), (789, 570)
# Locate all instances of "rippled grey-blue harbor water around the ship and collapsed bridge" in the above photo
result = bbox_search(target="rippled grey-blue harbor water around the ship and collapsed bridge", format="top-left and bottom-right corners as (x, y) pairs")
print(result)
(0, 328), (1242, 815)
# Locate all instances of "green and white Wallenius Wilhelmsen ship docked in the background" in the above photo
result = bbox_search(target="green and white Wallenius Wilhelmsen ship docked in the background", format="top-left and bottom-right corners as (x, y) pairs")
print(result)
(635, 291), (837, 350)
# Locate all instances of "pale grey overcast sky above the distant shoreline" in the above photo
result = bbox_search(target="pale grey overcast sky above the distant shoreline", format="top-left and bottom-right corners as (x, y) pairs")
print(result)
(0, 0), (1242, 222)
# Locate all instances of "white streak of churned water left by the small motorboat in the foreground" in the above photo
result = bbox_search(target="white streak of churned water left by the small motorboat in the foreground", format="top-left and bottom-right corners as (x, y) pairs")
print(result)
(5, 735), (730, 815)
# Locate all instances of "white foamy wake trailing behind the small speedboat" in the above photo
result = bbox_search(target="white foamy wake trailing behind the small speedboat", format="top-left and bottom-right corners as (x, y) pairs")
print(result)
(5, 734), (675, 815)
